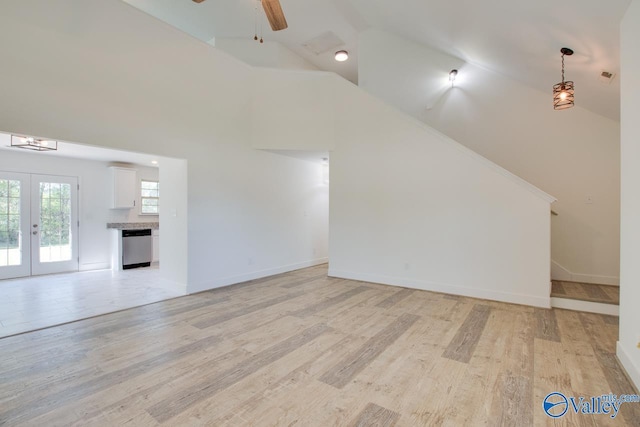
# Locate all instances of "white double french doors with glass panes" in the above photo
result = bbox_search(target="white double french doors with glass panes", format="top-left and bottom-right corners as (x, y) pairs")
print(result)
(0, 172), (78, 279)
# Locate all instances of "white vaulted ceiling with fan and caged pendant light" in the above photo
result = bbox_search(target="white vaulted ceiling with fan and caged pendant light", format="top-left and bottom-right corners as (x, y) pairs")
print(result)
(124, 0), (631, 120)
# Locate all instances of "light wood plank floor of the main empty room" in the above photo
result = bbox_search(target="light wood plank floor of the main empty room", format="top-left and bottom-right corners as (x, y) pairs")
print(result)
(0, 266), (640, 426)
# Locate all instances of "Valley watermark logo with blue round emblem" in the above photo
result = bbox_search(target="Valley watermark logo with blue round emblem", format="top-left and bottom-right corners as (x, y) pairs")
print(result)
(542, 391), (640, 418)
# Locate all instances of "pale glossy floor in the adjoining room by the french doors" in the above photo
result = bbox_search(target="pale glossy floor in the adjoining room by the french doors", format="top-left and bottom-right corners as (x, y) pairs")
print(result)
(0, 266), (186, 337)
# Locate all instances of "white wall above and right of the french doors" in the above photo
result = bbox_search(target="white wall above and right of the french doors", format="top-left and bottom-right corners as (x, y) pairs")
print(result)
(0, 150), (111, 270)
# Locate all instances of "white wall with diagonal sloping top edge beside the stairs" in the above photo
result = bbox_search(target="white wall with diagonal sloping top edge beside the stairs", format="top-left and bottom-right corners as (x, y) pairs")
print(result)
(329, 77), (553, 307)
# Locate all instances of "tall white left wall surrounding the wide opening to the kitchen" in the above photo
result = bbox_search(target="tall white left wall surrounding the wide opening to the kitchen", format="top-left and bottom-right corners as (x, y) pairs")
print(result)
(0, 0), (327, 292)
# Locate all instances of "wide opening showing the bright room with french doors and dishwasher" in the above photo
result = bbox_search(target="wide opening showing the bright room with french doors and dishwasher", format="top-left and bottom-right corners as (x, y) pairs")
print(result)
(0, 132), (187, 338)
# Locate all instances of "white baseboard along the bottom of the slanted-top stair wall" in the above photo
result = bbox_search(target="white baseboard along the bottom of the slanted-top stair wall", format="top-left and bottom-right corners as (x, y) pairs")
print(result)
(329, 266), (551, 308)
